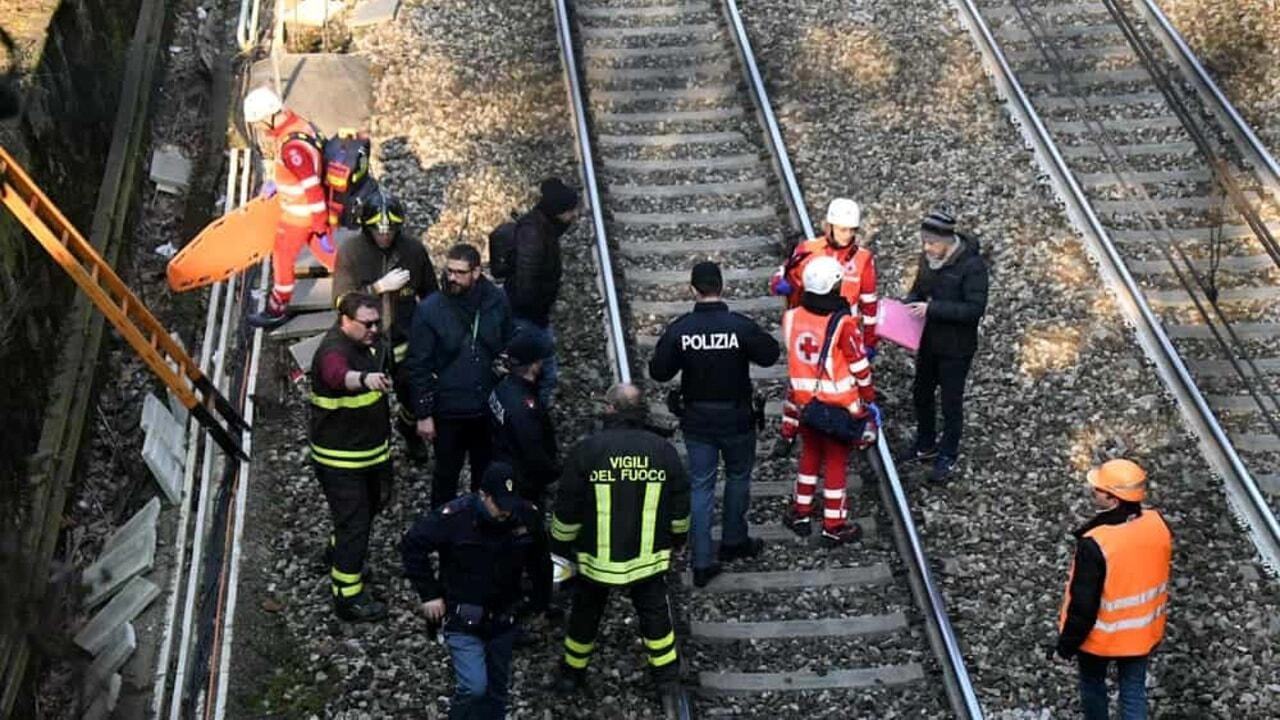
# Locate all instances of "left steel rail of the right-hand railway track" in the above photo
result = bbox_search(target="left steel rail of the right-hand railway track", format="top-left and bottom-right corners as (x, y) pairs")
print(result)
(951, 0), (1280, 571)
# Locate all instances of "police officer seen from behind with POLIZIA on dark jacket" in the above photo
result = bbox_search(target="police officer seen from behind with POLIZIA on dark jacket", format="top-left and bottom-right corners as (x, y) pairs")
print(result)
(649, 261), (781, 587)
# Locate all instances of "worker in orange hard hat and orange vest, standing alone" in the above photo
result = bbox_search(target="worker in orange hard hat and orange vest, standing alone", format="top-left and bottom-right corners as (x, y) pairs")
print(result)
(1056, 459), (1172, 720)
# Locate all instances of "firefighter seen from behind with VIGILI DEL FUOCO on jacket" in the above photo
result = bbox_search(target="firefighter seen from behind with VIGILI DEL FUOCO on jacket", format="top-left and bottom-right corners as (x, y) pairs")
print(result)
(552, 384), (689, 716)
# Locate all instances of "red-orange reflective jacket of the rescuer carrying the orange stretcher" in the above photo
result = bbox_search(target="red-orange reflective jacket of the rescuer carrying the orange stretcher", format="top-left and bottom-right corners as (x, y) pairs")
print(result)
(271, 110), (329, 232)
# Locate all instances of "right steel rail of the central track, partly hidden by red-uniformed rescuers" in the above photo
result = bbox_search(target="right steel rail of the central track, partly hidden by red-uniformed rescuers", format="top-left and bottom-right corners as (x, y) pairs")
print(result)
(724, 0), (983, 720)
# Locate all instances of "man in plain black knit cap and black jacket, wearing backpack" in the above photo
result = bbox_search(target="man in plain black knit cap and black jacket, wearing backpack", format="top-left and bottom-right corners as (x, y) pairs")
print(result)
(503, 178), (579, 407)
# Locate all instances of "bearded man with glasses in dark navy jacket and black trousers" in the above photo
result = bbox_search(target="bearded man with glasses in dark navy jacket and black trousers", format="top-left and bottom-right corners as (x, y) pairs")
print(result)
(407, 243), (512, 507)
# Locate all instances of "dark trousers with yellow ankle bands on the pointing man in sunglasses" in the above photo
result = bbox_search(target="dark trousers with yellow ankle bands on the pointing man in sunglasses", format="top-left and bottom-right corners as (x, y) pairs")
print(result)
(314, 461), (394, 598)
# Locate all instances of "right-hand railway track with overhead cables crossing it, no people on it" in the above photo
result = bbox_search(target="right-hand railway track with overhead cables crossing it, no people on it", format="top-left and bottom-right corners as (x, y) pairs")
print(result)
(957, 0), (1280, 568)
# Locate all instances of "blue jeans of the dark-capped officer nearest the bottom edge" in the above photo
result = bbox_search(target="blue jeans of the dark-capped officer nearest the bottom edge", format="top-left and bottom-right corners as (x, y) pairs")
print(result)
(444, 625), (516, 720)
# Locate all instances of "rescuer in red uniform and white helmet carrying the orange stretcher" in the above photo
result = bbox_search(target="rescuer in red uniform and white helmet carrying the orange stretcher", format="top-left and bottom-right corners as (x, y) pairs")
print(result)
(243, 87), (337, 328)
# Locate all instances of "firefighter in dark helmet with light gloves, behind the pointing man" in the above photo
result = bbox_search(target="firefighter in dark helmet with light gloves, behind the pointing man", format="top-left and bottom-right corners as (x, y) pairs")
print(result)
(333, 188), (439, 464)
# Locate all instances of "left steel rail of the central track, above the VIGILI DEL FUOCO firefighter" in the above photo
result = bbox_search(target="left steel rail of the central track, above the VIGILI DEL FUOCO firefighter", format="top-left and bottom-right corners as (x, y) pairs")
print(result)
(552, 0), (631, 383)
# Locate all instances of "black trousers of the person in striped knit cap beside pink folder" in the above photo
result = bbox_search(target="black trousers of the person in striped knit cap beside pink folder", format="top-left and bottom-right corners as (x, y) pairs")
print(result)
(911, 348), (973, 459)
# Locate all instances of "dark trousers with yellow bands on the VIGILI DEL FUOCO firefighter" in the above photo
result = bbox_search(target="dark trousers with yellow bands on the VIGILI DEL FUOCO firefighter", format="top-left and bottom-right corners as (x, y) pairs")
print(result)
(564, 573), (680, 685)
